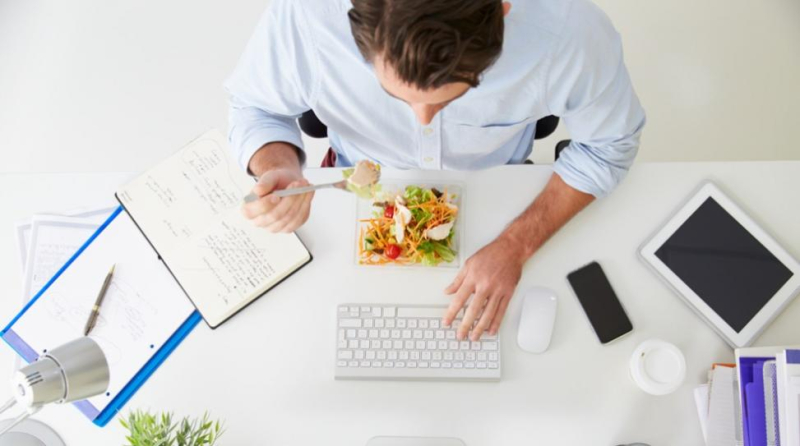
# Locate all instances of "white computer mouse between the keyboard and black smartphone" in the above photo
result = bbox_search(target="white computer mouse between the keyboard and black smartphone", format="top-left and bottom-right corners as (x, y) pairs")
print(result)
(517, 287), (558, 353)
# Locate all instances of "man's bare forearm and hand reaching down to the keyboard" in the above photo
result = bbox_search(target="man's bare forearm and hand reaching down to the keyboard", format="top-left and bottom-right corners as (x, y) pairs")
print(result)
(443, 174), (594, 341)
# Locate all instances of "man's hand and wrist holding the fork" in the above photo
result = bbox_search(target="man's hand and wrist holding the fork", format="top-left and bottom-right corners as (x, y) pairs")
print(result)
(242, 142), (314, 232)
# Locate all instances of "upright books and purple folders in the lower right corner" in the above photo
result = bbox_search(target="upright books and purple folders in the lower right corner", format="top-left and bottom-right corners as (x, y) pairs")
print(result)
(695, 347), (800, 446)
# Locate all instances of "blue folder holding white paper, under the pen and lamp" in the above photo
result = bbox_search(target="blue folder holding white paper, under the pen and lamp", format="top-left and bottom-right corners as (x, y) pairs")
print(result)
(0, 207), (202, 426)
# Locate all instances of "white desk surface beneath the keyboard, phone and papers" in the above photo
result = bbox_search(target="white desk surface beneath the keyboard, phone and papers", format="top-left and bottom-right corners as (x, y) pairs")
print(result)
(0, 161), (800, 446)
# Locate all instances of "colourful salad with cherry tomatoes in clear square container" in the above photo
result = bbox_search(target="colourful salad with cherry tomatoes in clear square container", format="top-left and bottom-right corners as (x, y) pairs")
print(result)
(358, 186), (458, 266)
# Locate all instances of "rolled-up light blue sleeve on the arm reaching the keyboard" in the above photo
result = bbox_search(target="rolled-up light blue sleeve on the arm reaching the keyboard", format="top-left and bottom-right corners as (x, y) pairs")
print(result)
(546, 0), (646, 197)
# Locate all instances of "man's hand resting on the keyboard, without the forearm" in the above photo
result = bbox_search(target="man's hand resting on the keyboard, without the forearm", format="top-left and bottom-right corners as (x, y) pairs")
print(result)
(444, 236), (527, 341)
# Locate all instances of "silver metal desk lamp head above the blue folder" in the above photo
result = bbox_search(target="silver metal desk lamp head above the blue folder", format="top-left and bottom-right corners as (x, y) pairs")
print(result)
(0, 337), (109, 444)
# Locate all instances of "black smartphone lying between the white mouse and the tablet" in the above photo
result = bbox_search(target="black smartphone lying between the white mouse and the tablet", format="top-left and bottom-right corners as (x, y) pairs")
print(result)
(567, 262), (633, 344)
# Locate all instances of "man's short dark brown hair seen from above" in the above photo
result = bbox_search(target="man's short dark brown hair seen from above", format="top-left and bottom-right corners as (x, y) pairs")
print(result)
(347, 0), (503, 90)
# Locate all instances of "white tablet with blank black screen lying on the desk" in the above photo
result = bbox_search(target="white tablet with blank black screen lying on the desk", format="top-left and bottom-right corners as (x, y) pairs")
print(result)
(639, 182), (800, 347)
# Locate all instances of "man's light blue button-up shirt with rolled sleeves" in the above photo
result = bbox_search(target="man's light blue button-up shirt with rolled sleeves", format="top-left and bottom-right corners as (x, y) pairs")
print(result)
(225, 0), (645, 197)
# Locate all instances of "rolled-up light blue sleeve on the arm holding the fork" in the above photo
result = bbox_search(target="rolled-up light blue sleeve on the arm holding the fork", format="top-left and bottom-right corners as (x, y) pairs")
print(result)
(225, 0), (317, 170)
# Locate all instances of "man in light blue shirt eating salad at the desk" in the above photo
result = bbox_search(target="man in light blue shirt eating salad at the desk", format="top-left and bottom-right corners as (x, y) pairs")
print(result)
(226, 0), (645, 340)
